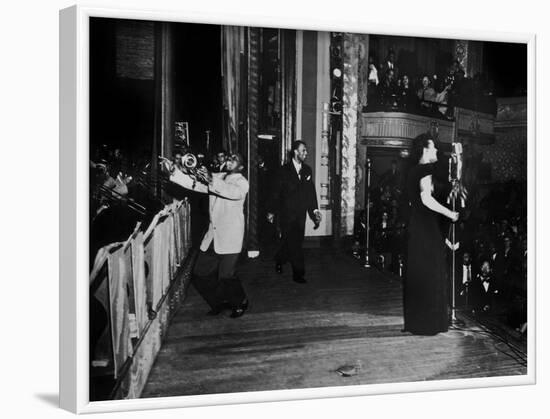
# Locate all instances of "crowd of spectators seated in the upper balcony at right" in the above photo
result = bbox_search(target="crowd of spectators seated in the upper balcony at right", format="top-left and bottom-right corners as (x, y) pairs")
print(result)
(363, 50), (496, 120)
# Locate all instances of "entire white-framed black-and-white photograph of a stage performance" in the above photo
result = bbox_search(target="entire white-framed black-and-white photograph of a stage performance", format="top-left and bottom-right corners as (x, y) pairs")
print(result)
(60, 6), (536, 413)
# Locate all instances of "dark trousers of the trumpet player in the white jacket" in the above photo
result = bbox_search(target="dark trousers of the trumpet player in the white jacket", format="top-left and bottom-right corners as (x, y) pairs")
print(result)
(192, 248), (246, 308)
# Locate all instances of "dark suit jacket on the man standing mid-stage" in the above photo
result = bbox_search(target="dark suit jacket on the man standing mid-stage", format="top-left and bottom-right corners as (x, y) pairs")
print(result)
(268, 161), (318, 228)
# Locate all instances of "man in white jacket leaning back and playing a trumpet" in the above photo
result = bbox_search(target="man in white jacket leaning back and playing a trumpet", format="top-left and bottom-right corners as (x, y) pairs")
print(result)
(167, 154), (248, 318)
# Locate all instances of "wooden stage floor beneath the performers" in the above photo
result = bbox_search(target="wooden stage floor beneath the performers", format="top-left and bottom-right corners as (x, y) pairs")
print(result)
(142, 248), (527, 397)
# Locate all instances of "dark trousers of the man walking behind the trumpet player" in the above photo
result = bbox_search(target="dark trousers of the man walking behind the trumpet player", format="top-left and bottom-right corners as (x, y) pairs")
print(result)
(275, 216), (306, 277)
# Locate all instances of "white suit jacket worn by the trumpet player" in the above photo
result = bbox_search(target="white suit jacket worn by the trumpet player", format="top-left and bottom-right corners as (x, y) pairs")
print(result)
(170, 169), (248, 255)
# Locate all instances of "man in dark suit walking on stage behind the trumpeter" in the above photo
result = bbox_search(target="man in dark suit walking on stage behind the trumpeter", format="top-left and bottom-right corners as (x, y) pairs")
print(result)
(267, 141), (321, 283)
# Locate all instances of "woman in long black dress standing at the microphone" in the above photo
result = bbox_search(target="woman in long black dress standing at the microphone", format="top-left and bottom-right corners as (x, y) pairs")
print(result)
(403, 134), (458, 335)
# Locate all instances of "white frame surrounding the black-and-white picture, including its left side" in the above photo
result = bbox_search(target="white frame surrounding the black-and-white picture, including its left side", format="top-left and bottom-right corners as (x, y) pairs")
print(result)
(59, 5), (537, 413)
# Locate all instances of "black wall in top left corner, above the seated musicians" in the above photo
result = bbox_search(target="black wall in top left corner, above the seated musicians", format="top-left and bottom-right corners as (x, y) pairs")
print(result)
(90, 18), (154, 162)
